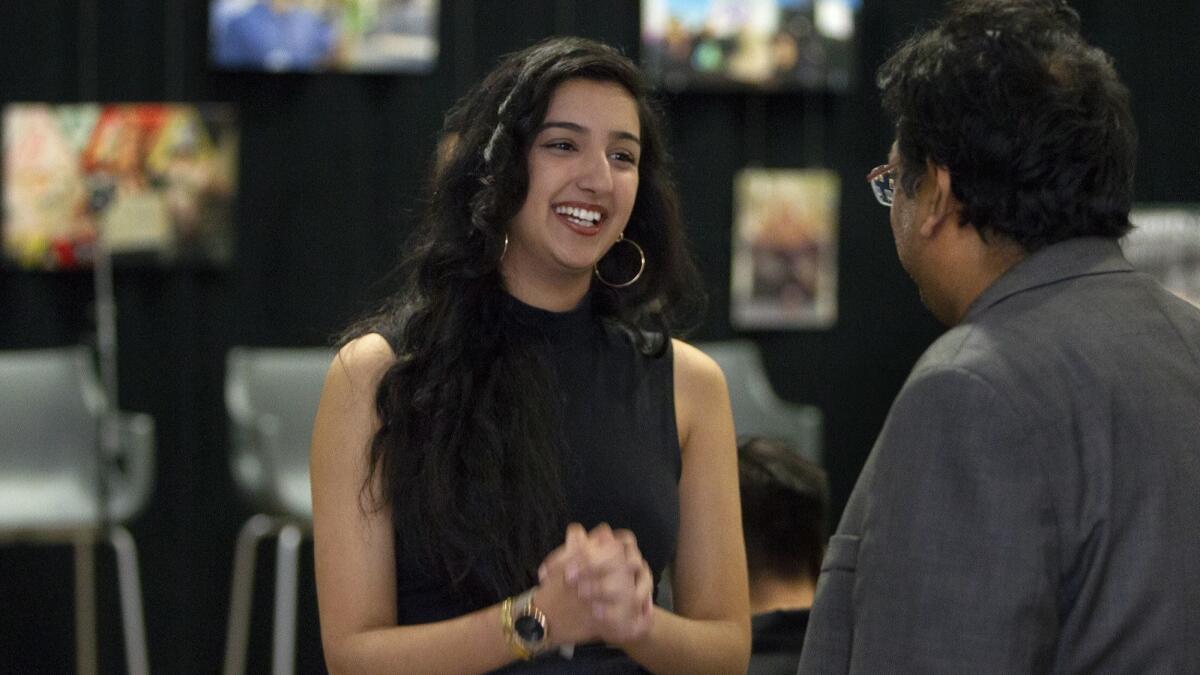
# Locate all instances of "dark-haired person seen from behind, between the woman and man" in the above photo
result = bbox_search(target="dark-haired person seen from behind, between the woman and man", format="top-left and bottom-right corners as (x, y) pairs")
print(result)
(738, 436), (829, 675)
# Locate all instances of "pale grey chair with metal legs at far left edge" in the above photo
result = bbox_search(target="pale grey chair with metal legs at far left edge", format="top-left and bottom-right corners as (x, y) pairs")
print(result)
(0, 347), (154, 675)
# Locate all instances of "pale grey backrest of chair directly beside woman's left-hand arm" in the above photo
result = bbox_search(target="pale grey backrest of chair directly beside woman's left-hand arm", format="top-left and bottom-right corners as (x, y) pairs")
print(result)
(226, 347), (334, 518)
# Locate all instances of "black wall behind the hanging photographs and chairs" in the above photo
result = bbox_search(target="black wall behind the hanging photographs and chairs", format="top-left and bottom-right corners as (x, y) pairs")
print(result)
(0, 0), (1200, 673)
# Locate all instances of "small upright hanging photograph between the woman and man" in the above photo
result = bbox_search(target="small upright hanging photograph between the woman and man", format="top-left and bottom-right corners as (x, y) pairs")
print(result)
(730, 168), (840, 329)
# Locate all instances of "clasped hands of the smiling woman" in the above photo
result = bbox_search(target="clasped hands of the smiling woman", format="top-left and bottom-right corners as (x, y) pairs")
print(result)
(534, 522), (654, 646)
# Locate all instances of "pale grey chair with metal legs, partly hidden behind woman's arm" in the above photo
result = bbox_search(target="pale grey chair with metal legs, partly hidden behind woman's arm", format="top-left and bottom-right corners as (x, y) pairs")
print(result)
(224, 347), (334, 675)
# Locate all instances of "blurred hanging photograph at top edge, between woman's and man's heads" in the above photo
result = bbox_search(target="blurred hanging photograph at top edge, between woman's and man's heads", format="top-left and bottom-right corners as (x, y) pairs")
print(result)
(642, 0), (862, 91)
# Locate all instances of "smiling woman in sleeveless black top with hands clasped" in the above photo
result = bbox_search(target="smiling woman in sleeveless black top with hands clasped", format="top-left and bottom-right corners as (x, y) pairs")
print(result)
(312, 38), (749, 673)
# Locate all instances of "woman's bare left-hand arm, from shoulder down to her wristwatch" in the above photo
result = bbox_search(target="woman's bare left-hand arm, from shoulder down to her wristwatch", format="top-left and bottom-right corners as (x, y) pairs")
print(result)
(310, 335), (512, 673)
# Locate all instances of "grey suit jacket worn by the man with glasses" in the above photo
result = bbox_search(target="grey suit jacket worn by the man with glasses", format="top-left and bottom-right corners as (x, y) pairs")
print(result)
(799, 239), (1200, 675)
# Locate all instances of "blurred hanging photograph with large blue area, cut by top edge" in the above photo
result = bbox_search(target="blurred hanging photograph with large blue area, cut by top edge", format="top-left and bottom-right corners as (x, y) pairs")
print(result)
(209, 0), (438, 72)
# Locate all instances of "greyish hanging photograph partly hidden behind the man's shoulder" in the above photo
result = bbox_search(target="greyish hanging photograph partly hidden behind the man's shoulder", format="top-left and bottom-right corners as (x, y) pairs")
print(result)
(1121, 204), (1200, 307)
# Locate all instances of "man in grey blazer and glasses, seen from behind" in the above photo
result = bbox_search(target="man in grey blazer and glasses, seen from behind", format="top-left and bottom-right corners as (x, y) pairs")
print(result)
(799, 0), (1200, 675)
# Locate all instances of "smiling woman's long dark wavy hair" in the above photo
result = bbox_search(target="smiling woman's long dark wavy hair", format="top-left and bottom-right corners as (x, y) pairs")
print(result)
(344, 37), (702, 603)
